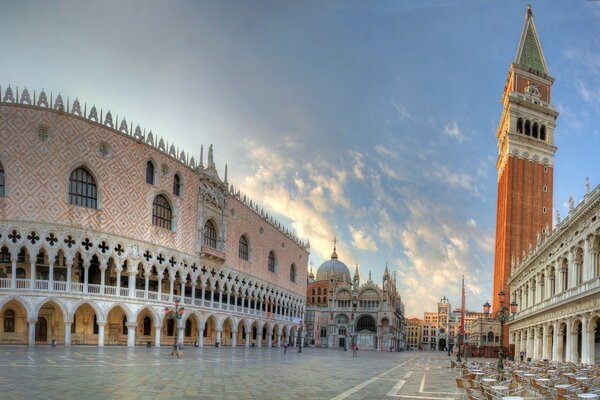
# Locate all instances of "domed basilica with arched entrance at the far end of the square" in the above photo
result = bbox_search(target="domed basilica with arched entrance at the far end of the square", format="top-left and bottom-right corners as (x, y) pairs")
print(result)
(306, 247), (406, 350)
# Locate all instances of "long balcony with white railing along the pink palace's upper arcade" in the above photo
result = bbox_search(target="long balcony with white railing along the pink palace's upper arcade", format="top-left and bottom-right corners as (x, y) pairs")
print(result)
(0, 278), (293, 322)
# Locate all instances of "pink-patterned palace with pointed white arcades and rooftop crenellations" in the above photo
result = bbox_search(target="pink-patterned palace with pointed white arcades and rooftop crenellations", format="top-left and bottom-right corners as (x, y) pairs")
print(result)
(0, 87), (309, 346)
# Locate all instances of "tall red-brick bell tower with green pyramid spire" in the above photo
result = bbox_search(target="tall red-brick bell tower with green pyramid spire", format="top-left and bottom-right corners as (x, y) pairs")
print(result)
(492, 6), (558, 328)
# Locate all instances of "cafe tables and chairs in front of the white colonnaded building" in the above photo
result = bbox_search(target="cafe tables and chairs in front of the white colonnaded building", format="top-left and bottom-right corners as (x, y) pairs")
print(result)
(451, 361), (600, 400)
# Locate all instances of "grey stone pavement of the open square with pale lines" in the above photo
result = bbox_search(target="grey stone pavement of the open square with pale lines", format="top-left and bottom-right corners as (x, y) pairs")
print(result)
(0, 346), (455, 400)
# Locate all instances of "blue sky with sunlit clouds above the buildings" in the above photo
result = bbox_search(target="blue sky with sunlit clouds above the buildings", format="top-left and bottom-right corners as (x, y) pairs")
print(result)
(0, 0), (600, 317)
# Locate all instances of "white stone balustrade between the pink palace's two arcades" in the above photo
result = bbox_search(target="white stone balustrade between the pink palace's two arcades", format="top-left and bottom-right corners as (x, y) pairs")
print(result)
(0, 278), (292, 322)
